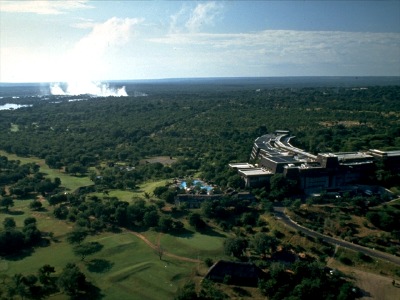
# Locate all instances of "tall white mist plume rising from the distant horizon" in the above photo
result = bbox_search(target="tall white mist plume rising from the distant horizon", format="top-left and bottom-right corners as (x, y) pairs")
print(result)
(50, 17), (142, 96)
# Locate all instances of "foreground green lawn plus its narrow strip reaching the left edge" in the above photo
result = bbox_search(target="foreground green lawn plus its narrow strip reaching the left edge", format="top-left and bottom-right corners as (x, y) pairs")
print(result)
(0, 232), (197, 299)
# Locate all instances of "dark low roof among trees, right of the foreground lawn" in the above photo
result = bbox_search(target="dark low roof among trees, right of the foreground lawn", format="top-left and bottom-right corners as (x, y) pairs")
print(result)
(205, 260), (265, 286)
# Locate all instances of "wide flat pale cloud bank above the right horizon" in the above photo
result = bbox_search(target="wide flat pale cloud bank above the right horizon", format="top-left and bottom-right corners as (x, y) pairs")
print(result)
(150, 30), (400, 76)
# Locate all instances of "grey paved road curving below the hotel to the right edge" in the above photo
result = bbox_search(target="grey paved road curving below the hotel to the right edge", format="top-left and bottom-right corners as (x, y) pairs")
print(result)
(274, 206), (400, 266)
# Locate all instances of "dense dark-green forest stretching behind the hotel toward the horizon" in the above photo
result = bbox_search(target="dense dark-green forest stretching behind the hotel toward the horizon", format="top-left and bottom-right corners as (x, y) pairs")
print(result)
(0, 86), (400, 184)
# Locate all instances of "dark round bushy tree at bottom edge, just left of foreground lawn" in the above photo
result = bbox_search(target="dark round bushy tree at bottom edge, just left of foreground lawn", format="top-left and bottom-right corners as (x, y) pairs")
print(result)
(57, 263), (87, 297)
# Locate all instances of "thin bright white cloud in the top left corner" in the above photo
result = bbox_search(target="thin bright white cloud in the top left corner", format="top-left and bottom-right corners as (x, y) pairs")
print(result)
(0, 0), (93, 15)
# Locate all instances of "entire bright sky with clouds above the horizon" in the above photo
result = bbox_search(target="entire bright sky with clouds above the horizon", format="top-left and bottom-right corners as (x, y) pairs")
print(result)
(0, 0), (400, 82)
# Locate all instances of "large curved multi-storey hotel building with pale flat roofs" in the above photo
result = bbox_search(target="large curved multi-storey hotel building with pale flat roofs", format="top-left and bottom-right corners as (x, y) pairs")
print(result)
(230, 130), (400, 193)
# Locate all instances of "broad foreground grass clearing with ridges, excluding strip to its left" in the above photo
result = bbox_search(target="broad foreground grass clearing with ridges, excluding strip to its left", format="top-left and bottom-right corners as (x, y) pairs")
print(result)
(83, 233), (195, 299)
